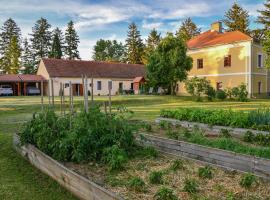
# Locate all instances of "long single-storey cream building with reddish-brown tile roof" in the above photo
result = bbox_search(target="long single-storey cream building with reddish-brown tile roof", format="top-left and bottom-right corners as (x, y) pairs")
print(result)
(37, 58), (145, 96)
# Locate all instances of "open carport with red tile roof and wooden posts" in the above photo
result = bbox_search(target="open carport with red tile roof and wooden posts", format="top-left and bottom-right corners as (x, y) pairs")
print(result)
(0, 74), (47, 96)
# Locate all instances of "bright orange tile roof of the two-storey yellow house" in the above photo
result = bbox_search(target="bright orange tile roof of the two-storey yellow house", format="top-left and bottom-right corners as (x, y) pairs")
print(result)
(187, 30), (252, 49)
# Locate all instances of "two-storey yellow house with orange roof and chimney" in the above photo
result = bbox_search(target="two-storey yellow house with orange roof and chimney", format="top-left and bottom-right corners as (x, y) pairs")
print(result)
(178, 22), (270, 97)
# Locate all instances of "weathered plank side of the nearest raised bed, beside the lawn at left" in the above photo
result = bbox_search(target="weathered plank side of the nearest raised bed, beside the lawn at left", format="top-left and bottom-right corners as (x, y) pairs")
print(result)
(13, 135), (123, 200)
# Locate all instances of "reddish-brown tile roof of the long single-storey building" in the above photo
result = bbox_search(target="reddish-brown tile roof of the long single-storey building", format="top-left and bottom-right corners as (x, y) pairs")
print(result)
(42, 58), (145, 79)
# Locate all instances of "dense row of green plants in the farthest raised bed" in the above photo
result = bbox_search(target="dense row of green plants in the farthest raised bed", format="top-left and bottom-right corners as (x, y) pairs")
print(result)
(160, 108), (270, 131)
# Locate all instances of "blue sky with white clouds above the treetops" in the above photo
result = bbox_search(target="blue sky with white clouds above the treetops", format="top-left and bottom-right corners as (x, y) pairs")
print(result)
(0, 0), (264, 60)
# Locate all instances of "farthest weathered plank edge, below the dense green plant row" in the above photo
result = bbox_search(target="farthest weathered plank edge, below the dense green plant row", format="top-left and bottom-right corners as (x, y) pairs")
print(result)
(155, 117), (269, 137)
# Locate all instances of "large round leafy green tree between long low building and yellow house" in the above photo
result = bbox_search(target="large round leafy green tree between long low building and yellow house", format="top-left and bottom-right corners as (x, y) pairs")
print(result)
(146, 34), (192, 94)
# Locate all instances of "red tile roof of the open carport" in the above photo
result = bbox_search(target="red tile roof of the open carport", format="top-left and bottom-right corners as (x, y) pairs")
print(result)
(0, 74), (45, 82)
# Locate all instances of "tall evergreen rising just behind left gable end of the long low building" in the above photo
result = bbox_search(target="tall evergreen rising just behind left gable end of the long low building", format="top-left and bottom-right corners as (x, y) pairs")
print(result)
(30, 18), (51, 64)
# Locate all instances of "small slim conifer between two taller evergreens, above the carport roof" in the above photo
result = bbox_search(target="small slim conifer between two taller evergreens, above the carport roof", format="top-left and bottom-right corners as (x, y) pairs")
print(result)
(21, 38), (35, 74)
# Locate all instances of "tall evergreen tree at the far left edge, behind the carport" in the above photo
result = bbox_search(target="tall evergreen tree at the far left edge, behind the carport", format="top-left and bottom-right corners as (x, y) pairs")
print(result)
(0, 18), (21, 72)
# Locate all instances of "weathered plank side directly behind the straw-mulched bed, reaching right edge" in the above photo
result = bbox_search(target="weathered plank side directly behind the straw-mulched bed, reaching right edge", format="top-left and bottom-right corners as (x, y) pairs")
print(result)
(137, 134), (270, 180)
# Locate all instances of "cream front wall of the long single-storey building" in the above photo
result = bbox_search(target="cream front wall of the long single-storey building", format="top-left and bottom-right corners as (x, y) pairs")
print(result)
(48, 78), (133, 96)
